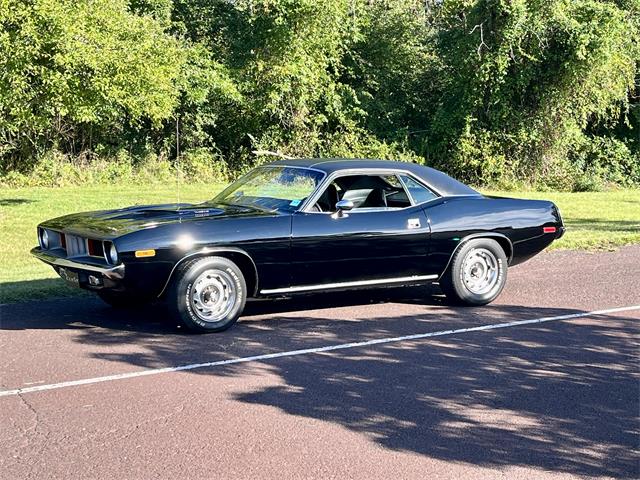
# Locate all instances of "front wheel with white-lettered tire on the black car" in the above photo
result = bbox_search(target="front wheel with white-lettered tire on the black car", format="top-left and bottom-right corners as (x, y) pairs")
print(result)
(167, 257), (247, 333)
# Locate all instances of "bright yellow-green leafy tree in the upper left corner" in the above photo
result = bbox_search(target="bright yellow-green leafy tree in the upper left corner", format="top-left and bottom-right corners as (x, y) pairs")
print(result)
(0, 0), (184, 168)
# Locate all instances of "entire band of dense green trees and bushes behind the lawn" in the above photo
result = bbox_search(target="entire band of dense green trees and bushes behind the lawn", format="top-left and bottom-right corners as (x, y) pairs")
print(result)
(0, 0), (640, 190)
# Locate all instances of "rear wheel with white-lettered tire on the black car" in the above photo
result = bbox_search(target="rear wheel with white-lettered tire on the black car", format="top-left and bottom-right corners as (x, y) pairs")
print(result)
(440, 238), (507, 306)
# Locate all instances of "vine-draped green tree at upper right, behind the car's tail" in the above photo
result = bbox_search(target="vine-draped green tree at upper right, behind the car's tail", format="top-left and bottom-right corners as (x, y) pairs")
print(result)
(427, 0), (639, 186)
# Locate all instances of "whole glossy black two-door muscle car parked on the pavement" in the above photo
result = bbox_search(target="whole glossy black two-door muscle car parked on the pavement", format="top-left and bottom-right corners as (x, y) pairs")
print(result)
(32, 159), (564, 332)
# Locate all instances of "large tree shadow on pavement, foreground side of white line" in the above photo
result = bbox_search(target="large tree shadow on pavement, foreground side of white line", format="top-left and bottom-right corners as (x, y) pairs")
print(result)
(236, 310), (640, 478)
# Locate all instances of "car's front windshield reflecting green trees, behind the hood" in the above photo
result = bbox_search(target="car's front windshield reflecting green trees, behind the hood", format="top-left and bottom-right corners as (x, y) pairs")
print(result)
(211, 167), (324, 212)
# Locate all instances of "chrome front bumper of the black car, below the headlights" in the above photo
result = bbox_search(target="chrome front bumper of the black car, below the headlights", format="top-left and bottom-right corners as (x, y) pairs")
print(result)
(31, 247), (125, 289)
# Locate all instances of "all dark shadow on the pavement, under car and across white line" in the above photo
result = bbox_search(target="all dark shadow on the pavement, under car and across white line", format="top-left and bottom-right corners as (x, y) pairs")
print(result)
(1, 289), (640, 478)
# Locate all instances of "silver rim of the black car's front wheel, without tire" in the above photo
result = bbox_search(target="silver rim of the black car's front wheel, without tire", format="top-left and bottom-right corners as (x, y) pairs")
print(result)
(189, 269), (237, 322)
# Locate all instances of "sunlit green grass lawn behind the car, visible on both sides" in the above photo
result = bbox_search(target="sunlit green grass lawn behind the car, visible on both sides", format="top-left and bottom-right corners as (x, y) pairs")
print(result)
(0, 185), (640, 303)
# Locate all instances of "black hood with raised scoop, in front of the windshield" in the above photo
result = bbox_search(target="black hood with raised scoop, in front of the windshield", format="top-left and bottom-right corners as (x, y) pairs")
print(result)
(41, 203), (277, 238)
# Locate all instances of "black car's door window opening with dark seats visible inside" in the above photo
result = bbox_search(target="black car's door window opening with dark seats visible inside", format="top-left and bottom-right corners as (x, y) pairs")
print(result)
(311, 174), (411, 213)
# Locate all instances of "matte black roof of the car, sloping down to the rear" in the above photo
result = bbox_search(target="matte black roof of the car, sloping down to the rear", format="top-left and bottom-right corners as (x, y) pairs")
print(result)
(272, 158), (479, 196)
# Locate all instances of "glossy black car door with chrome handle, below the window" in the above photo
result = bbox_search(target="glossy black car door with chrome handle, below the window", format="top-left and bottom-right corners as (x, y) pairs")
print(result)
(291, 174), (430, 288)
